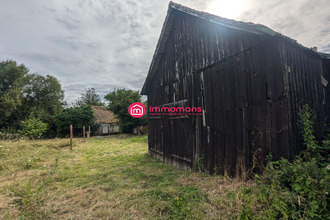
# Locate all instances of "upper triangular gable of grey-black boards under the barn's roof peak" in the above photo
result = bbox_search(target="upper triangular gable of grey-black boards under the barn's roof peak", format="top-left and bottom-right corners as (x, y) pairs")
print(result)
(150, 12), (262, 93)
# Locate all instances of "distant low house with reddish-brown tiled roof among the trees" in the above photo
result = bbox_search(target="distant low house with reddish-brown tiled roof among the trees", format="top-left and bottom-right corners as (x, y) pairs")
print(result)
(93, 106), (119, 135)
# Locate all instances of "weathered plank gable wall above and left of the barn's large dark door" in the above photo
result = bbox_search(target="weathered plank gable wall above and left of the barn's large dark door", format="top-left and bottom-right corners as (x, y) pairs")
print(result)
(148, 12), (261, 170)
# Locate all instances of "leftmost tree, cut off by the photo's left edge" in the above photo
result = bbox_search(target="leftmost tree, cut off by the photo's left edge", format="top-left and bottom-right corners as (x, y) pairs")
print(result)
(0, 60), (29, 128)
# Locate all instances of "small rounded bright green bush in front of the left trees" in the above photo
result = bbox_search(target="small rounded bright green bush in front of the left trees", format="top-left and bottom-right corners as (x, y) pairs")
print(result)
(18, 118), (48, 139)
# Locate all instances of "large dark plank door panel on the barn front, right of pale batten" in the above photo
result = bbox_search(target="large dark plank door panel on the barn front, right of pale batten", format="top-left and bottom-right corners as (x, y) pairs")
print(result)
(198, 39), (290, 174)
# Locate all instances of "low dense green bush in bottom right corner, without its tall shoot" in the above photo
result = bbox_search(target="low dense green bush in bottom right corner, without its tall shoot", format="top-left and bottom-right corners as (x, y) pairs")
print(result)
(241, 159), (330, 219)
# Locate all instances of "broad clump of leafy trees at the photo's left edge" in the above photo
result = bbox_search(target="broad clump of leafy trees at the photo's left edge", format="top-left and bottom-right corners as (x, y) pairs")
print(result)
(0, 60), (64, 130)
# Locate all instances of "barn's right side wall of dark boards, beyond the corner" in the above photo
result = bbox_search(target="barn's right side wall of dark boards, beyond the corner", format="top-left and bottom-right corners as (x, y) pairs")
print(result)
(278, 39), (330, 155)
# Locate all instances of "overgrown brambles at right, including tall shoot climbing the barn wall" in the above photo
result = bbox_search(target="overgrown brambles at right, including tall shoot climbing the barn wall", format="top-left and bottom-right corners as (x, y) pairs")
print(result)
(240, 105), (330, 219)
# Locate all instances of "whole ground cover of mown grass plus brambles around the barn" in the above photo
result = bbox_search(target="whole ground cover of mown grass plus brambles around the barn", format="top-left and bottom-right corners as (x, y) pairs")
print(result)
(0, 107), (330, 219)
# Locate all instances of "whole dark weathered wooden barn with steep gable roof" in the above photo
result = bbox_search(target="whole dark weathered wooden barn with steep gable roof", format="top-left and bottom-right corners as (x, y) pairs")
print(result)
(141, 2), (330, 174)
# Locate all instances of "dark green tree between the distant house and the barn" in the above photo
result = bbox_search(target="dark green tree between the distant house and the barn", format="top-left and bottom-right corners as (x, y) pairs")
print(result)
(104, 89), (145, 133)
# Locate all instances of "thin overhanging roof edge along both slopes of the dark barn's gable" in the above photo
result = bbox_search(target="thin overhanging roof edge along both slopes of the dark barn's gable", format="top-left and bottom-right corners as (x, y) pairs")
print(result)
(141, 2), (324, 95)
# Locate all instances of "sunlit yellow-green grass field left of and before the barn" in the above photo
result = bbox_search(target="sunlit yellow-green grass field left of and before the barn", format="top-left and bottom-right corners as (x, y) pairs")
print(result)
(0, 135), (248, 219)
